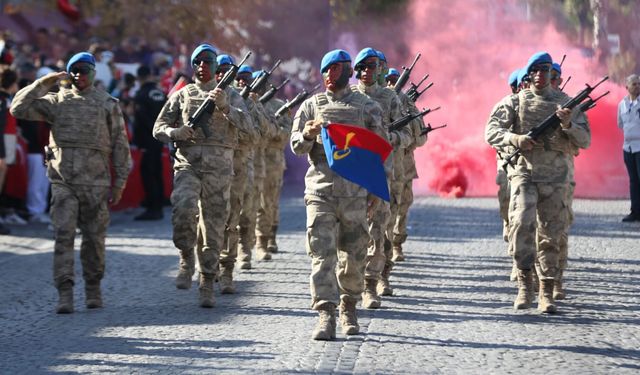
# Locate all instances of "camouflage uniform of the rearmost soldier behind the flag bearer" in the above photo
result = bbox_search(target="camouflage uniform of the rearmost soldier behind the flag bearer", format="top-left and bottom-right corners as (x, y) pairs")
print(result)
(392, 92), (427, 258)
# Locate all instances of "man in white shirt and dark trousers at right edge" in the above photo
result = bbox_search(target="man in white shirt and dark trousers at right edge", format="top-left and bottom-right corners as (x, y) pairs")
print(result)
(618, 74), (640, 222)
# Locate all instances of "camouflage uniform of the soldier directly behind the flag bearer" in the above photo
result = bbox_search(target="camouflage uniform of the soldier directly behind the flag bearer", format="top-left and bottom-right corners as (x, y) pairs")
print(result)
(351, 81), (410, 280)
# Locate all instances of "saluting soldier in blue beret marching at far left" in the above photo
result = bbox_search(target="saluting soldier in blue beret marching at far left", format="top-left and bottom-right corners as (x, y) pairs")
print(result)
(11, 52), (131, 314)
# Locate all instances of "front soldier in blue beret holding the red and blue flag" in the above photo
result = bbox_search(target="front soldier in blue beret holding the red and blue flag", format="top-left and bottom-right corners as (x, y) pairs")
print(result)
(291, 49), (386, 340)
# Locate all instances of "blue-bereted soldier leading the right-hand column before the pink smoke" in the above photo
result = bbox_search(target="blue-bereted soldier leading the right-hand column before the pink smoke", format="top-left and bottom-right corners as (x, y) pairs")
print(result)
(485, 52), (591, 313)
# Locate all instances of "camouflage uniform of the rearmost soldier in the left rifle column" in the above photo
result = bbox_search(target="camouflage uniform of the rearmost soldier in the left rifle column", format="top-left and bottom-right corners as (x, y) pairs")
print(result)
(256, 98), (292, 252)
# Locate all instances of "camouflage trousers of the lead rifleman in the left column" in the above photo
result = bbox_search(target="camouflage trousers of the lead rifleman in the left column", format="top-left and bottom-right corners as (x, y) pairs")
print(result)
(171, 169), (232, 277)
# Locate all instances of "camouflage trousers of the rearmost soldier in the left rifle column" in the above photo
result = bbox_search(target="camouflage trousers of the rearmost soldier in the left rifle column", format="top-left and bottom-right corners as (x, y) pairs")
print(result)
(256, 147), (285, 238)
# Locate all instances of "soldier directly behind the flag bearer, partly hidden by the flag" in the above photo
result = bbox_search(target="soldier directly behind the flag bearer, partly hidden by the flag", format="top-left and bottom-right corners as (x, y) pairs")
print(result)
(351, 48), (409, 309)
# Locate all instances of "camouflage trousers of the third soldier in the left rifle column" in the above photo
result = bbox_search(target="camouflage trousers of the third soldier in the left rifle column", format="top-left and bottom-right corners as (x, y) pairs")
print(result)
(238, 166), (264, 262)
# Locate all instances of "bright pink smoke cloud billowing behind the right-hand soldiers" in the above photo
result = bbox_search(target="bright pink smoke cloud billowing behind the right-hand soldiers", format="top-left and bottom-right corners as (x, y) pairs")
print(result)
(404, 0), (628, 198)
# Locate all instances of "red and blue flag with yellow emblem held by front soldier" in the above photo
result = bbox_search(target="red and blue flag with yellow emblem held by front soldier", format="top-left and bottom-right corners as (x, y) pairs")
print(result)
(322, 123), (392, 201)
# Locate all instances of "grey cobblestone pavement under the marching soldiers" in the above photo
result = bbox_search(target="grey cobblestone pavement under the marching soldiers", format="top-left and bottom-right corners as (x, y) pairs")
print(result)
(0, 197), (640, 374)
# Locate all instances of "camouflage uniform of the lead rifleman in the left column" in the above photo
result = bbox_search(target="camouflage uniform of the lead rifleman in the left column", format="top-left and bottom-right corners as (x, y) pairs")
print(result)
(153, 80), (254, 284)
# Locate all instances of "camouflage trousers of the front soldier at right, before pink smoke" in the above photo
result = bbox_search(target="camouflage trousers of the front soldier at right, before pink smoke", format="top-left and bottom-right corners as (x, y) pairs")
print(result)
(509, 176), (569, 280)
